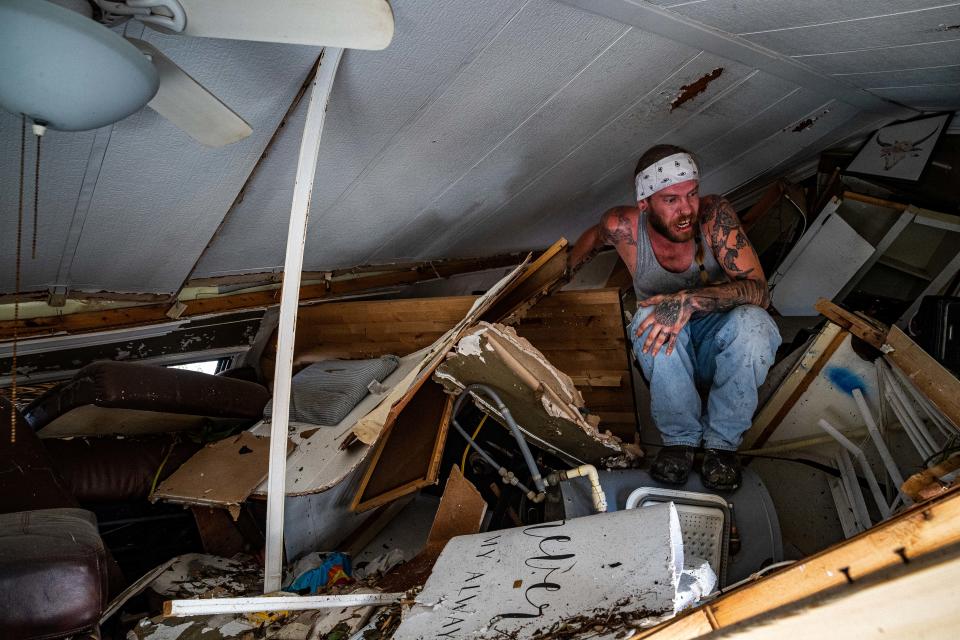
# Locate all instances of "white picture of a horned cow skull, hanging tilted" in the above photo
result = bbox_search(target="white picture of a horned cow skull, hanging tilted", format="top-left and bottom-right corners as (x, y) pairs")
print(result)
(846, 113), (950, 180)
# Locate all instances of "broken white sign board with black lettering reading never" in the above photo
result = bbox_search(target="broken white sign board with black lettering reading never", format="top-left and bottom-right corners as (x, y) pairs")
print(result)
(393, 503), (688, 640)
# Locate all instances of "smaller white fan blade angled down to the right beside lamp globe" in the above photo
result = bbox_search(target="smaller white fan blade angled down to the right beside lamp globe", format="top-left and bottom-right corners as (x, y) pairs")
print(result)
(128, 38), (253, 147)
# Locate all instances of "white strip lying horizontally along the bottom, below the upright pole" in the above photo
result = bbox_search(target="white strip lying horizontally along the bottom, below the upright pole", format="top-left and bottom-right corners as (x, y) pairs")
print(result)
(163, 593), (404, 618)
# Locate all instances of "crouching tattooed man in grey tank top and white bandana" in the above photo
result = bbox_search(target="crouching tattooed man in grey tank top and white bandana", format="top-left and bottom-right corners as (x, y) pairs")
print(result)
(569, 145), (780, 491)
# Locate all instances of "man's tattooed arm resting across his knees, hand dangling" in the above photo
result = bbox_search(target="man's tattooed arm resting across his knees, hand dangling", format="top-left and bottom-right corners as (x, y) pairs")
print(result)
(637, 196), (770, 355)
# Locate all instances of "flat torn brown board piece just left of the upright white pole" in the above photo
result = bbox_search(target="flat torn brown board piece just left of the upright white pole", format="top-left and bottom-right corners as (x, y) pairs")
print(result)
(150, 431), (293, 520)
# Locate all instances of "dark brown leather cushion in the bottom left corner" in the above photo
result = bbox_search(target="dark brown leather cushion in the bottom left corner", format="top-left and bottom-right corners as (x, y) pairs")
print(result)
(0, 509), (108, 638)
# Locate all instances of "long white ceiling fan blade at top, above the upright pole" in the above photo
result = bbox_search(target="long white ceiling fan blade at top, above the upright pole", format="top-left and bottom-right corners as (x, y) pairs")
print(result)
(172, 0), (393, 49)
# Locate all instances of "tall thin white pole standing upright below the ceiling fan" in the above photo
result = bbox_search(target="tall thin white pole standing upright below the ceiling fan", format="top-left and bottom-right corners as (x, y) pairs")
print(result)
(263, 47), (343, 593)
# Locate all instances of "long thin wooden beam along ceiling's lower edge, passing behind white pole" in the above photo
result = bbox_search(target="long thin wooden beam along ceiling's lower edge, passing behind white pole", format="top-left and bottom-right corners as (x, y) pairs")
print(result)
(0, 254), (517, 341)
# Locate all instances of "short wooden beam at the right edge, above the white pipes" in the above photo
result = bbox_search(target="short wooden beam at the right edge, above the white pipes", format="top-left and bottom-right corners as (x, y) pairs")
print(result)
(886, 327), (960, 426)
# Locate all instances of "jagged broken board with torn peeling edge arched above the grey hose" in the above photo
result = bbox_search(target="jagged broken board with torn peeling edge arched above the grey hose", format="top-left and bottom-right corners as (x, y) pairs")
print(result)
(434, 322), (629, 466)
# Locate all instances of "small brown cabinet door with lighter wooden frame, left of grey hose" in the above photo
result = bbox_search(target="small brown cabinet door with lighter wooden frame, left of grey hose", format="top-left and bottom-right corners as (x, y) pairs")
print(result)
(350, 382), (453, 511)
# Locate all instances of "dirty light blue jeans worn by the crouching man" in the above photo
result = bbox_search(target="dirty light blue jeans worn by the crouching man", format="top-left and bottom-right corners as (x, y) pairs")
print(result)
(629, 305), (780, 451)
